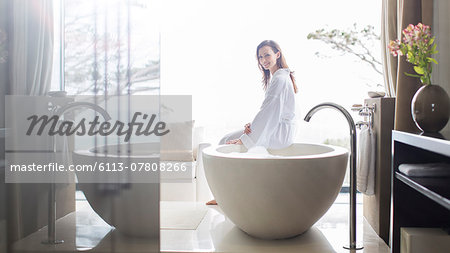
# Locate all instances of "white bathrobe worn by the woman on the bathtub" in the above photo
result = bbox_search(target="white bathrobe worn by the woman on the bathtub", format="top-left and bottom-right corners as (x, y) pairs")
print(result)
(240, 69), (295, 149)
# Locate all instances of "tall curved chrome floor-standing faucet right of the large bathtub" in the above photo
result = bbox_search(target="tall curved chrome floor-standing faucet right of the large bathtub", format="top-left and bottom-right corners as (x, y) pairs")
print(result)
(305, 103), (363, 250)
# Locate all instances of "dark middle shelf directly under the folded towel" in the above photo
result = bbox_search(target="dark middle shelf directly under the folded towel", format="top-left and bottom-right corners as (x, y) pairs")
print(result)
(395, 172), (450, 210)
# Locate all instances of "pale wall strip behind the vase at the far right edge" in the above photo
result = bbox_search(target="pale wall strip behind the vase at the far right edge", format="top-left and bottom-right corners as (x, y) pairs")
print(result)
(432, 0), (450, 131)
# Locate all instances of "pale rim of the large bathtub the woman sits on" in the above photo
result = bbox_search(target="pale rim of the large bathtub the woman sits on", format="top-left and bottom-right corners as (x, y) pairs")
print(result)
(203, 142), (350, 160)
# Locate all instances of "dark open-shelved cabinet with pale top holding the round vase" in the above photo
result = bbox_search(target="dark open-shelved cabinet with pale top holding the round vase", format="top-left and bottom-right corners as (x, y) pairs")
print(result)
(390, 131), (450, 253)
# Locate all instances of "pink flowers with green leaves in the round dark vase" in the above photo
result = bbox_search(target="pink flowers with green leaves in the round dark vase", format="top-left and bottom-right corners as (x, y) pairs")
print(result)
(388, 23), (438, 85)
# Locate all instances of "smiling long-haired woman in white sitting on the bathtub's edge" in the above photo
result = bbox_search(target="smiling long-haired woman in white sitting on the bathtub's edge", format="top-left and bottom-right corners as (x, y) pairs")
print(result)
(206, 40), (297, 205)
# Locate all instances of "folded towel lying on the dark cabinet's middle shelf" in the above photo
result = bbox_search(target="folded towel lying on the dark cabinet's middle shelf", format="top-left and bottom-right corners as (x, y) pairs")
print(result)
(398, 163), (450, 177)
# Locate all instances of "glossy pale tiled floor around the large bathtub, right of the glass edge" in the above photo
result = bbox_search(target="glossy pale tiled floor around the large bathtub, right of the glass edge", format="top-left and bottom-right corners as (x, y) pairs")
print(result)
(161, 194), (389, 253)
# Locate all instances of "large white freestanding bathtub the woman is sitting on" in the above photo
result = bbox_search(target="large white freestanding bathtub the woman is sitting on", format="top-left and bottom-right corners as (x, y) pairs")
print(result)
(203, 143), (348, 239)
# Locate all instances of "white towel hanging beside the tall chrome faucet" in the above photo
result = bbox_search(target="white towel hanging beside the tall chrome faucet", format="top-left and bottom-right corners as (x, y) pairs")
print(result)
(356, 126), (376, 195)
